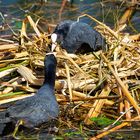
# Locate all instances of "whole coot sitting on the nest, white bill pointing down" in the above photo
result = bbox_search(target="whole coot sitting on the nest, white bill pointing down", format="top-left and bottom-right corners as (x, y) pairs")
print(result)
(51, 20), (106, 53)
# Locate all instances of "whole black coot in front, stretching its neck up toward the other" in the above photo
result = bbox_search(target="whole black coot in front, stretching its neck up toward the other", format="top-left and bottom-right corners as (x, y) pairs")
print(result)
(0, 54), (59, 135)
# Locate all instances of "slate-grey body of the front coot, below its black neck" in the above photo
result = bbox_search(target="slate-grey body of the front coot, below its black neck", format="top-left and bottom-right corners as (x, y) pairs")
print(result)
(8, 86), (58, 127)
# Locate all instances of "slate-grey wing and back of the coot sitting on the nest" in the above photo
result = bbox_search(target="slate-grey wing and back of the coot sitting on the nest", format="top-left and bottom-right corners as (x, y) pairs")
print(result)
(64, 22), (96, 53)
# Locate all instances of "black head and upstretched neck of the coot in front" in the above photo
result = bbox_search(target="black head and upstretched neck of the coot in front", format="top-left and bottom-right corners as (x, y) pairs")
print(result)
(44, 54), (57, 86)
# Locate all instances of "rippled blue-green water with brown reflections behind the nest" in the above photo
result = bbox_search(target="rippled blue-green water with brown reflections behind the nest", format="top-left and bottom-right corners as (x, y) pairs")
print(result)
(0, 0), (140, 33)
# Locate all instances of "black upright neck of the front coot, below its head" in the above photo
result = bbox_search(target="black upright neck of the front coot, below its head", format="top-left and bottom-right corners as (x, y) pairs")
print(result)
(44, 65), (56, 87)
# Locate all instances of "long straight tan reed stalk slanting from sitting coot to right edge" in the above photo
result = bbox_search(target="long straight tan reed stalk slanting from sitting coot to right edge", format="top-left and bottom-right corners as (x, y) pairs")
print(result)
(101, 53), (140, 114)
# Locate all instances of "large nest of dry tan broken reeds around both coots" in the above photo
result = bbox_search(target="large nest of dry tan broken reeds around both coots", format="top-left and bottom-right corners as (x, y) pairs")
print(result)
(0, 15), (140, 139)
